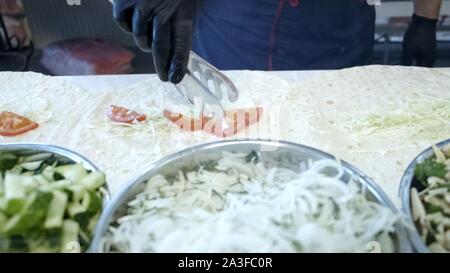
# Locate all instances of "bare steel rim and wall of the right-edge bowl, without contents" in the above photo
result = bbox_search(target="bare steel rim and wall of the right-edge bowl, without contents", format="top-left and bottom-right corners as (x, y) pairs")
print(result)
(399, 139), (450, 253)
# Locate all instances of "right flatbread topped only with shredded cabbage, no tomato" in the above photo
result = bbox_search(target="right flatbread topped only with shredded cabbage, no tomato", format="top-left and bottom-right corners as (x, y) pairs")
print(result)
(280, 66), (450, 200)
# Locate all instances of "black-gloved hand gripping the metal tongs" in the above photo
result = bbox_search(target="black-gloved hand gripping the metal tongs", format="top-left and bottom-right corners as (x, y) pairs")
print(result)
(113, 0), (196, 84)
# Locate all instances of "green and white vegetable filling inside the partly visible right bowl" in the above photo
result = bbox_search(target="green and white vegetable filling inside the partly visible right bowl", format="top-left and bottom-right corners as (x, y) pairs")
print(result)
(411, 143), (450, 252)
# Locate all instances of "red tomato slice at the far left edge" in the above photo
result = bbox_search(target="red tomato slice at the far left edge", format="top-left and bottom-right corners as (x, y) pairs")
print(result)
(0, 111), (39, 137)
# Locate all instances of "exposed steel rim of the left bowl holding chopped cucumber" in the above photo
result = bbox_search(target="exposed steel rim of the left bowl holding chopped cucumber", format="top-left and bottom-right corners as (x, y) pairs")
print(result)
(0, 143), (111, 252)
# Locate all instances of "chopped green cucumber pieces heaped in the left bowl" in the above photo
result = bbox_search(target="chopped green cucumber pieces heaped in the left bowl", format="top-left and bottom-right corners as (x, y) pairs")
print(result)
(0, 152), (106, 252)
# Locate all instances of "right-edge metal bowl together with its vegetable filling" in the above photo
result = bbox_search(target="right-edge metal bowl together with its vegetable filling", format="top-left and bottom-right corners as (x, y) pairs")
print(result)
(399, 139), (450, 253)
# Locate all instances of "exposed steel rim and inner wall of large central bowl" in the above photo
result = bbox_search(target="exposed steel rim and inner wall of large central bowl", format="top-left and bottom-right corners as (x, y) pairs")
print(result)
(92, 140), (411, 252)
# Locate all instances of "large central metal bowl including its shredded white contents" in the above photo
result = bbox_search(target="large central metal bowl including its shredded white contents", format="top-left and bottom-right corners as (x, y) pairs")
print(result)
(92, 140), (410, 253)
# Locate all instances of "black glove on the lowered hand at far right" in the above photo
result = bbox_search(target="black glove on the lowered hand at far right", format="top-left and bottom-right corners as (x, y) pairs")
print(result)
(401, 14), (438, 67)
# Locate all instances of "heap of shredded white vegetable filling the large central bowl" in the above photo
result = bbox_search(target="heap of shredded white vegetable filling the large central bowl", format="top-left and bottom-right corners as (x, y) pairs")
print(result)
(102, 153), (399, 252)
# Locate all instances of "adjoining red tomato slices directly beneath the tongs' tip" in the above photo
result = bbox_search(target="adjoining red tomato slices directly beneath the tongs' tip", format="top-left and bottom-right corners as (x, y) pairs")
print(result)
(164, 107), (263, 137)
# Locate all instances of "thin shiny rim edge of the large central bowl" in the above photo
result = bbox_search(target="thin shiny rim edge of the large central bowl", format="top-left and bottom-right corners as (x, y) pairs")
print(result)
(92, 139), (411, 252)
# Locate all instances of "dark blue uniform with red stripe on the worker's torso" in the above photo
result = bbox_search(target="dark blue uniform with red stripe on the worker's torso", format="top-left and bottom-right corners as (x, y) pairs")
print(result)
(193, 0), (375, 70)
